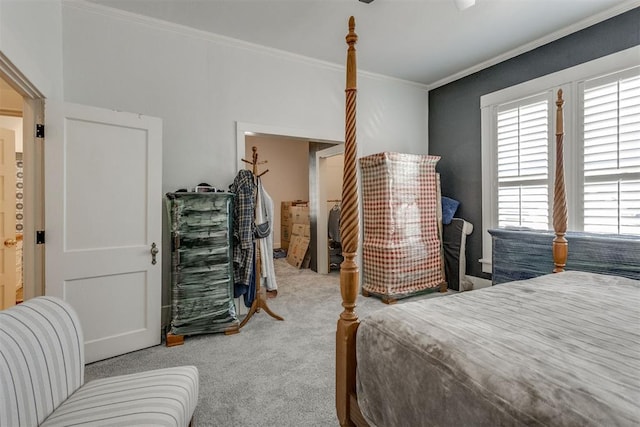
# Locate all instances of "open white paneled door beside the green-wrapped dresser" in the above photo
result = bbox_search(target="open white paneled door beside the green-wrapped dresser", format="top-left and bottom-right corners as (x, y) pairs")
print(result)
(45, 104), (163, 363)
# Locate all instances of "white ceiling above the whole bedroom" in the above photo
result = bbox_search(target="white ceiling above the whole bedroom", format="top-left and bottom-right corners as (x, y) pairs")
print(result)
(89, 0), (640, 87)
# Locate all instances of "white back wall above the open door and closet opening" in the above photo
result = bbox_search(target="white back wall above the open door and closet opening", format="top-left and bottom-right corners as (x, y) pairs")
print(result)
(62, 2), (428, 310)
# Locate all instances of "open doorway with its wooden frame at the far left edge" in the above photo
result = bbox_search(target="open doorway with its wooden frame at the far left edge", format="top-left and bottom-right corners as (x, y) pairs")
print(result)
(0, 52), (44, 308)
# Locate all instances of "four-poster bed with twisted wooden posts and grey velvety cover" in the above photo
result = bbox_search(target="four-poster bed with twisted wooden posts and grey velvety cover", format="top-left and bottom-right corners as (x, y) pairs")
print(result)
(336, 17), (640, 427)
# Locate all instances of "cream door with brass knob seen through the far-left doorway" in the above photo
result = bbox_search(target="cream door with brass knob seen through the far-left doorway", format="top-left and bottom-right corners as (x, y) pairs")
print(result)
(0, 128), (17, 310)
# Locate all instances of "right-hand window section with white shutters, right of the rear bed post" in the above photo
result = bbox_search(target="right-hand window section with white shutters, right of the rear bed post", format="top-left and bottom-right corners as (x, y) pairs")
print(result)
(580, 69), (640, 235)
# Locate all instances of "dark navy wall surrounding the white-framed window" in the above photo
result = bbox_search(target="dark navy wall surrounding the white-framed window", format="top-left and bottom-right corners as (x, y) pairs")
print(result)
(429, 8), (640, 278)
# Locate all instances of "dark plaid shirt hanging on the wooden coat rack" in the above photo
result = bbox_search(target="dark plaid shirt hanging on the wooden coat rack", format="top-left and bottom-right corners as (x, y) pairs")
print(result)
(229, 169), (257, 298)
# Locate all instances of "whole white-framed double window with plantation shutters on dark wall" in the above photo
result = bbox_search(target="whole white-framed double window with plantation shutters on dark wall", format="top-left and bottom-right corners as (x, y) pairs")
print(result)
(480, 46), (640, 272)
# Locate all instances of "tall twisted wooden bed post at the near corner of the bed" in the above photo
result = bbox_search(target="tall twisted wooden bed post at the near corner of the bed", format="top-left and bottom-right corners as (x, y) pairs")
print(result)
(336, 16), (359, 426)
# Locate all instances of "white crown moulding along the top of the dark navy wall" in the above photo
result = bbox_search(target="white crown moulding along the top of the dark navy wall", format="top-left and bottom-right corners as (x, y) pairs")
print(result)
(428, 0), (640, 90)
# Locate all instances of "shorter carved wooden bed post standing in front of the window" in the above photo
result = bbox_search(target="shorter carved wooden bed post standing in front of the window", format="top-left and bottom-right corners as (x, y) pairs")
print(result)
(553, 89), (569, 273)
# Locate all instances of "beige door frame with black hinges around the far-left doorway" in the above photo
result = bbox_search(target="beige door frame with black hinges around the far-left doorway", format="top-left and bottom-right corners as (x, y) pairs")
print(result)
(0, 52), (45, 300)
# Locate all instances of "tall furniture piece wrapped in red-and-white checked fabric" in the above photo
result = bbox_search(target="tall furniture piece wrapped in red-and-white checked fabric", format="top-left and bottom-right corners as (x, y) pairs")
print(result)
(360, 152), (444, 302)
